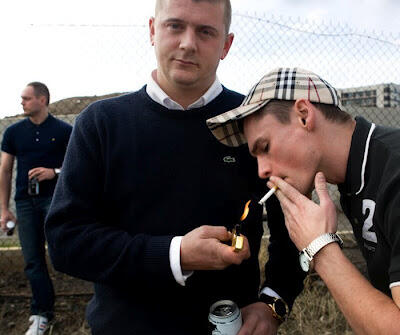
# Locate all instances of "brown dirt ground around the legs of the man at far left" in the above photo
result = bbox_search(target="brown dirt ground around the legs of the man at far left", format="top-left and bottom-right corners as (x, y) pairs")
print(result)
(0, 250), (93, 335)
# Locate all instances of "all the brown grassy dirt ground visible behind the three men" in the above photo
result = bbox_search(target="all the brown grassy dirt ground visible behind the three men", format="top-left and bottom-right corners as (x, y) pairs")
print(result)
(0, 235), (365, 335)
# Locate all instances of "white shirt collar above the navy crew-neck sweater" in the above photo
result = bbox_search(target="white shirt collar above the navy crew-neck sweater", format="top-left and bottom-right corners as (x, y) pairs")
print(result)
(146, 70), (222, 110)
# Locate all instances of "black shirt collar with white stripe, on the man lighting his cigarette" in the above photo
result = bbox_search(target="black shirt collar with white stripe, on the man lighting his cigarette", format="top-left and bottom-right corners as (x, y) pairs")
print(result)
(339, 117), (376, 195)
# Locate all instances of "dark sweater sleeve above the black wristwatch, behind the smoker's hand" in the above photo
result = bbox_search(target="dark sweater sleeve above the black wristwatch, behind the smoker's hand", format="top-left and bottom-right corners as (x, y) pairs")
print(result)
(263, 196), (306, 309)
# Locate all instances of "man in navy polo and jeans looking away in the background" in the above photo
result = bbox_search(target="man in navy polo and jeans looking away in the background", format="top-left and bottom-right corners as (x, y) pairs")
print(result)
(0, 82), (72, 335)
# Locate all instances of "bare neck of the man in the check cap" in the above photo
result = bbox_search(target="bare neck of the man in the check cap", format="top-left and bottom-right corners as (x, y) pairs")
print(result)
(320, 120), (356, 184)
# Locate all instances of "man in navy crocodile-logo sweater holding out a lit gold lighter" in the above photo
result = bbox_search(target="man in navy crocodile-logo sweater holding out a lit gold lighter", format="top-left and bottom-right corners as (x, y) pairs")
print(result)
(46, 0), (304, 335)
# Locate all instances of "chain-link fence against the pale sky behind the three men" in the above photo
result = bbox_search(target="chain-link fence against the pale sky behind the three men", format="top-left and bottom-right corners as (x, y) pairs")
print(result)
(0, 13), (400, 286)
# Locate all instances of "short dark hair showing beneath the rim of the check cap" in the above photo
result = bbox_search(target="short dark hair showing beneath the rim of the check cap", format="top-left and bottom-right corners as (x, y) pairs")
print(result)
(256, 99), (351, 124)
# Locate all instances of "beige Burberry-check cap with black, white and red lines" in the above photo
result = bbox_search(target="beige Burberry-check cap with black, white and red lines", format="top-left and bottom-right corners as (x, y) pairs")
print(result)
(207, 68), (340, 147)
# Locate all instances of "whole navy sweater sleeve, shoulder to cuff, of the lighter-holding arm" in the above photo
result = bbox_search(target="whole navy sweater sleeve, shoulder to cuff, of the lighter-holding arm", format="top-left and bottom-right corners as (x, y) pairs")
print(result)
(45, 107), (177, 285)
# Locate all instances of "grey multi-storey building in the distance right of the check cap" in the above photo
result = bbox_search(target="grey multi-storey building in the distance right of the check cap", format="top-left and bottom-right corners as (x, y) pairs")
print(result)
(338, 83), (400, 108)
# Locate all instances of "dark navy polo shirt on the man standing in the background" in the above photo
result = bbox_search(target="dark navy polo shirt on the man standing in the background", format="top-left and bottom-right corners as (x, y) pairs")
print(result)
(1, 114), (72, 200)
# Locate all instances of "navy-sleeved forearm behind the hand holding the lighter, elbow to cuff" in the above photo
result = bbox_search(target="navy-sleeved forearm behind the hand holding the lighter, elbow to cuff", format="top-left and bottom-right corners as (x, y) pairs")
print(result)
(46, 203), (175, 286)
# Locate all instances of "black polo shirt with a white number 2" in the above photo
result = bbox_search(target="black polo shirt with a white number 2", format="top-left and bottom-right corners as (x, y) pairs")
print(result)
(339, 117), (400, 295)
